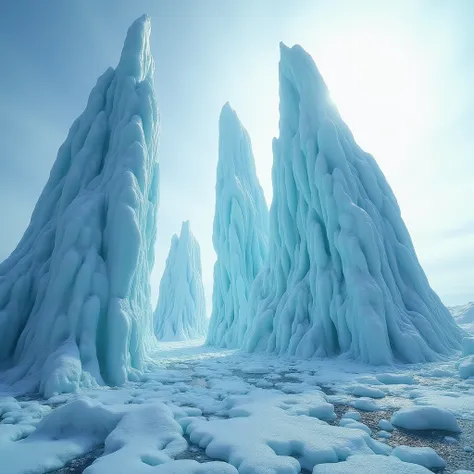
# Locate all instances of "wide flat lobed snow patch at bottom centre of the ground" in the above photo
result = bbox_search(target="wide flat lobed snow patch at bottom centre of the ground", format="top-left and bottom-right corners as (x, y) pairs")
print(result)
(186, 390), (390, 474)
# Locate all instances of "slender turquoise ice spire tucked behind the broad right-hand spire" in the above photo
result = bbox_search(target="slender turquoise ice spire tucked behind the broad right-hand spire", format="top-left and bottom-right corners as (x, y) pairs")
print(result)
(207, 103), (268, 348)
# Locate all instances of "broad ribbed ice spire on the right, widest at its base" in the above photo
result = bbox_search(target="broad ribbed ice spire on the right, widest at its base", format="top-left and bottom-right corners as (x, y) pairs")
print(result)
(245, 45), (461, 364)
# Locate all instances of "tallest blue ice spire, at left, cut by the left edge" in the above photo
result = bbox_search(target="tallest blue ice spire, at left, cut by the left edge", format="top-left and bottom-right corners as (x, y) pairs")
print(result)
(0, 16), (158, 397)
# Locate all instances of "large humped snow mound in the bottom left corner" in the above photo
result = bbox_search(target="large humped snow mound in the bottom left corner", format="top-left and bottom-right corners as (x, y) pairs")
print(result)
(0, 399), (237, 474)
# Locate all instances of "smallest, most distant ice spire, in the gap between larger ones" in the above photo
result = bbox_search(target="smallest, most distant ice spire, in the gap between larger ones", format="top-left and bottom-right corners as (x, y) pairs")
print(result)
(155, 221), (207, 341)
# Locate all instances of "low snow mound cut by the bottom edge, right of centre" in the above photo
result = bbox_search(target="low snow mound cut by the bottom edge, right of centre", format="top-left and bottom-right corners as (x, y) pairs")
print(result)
(313, 455), (431, 474)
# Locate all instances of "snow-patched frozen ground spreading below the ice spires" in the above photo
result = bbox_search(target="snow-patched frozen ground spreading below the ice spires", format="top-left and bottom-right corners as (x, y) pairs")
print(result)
(0, 340), (474, 474)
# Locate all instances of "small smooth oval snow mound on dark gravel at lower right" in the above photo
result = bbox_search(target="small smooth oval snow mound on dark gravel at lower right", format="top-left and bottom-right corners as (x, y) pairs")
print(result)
(391, 406), (461, 433)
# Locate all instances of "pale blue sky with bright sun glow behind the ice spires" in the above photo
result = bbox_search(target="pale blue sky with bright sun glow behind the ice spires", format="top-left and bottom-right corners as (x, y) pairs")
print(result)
(0, 0), (474, 311)
